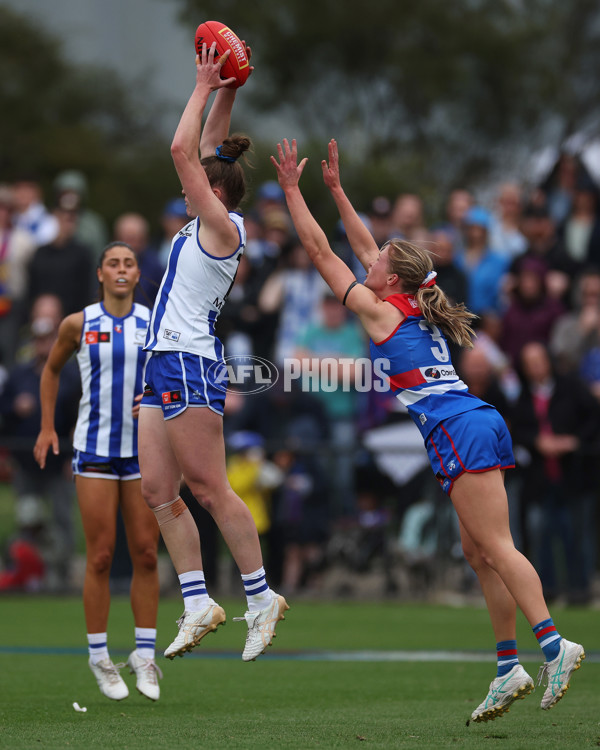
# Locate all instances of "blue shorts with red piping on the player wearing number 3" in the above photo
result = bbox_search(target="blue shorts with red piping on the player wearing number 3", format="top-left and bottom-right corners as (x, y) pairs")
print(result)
(425, 406), (515, 495)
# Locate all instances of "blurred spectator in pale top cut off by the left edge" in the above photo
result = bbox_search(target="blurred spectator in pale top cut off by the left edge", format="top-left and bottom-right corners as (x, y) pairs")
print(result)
(0, 185), (35, 366)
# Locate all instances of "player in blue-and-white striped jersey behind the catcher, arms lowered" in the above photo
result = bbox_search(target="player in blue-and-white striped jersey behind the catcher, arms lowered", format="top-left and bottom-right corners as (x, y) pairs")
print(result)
(34, 242), (162, 700)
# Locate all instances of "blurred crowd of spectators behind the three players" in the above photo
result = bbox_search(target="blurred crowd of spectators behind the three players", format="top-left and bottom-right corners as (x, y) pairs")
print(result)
(0, 154), (600, 602)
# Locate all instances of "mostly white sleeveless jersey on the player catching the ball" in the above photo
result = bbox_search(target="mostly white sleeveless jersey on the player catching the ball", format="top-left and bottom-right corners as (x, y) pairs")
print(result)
(145, 212), (246, 361)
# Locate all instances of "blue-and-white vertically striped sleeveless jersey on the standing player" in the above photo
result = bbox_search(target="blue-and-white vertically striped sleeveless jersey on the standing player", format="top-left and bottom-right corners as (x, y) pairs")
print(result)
(73, 302), (150, 458)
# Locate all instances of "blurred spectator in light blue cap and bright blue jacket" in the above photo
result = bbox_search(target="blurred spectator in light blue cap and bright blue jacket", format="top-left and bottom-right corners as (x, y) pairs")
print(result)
(456, 206), (508, 315)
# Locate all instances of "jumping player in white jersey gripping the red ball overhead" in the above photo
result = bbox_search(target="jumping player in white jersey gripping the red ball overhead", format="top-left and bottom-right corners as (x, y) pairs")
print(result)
(140, 45), (288, 661)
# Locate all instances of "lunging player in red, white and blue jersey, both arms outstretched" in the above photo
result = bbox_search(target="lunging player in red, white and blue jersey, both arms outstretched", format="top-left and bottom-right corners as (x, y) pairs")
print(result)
(271, 140), (585, 721)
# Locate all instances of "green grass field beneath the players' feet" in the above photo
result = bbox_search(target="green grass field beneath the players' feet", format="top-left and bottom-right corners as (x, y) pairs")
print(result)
(0, 597), (600, 750)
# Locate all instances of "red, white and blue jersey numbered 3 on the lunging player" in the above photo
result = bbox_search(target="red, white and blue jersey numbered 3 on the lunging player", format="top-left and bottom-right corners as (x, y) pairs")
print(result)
(370, 294), (486, 439)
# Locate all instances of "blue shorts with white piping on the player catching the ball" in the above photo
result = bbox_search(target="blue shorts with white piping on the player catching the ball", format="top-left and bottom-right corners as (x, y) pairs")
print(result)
(141, 352), (227, 419)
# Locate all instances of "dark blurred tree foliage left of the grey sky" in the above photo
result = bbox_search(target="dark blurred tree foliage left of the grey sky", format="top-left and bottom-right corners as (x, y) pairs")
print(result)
(0, 7), (179, 226)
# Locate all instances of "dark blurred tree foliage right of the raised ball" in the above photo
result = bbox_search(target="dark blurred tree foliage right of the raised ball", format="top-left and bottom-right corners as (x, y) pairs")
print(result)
(179, 0), (600, 220)
